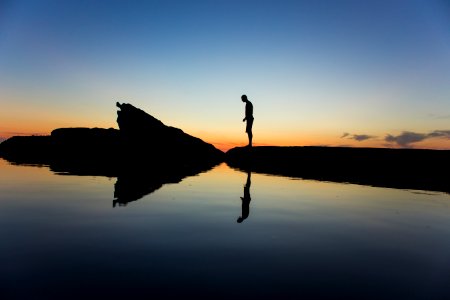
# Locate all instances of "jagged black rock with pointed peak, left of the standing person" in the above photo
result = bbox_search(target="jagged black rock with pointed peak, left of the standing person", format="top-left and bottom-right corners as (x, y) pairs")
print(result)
(0, 103), (224, 176)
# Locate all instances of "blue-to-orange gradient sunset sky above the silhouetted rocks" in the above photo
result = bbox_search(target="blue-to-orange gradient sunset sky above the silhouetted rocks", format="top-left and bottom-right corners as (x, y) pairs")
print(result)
(0, 0), (450, 149)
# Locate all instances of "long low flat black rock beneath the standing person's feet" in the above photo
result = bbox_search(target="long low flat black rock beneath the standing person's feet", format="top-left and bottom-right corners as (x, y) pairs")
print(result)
(226, 147), (450, 193)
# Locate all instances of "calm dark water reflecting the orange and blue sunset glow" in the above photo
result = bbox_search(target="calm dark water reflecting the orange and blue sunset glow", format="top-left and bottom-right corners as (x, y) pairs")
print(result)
(0, 160), (450, 299)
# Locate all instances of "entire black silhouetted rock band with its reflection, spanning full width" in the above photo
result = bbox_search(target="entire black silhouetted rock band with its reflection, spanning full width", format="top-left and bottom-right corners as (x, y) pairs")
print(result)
(0, 103), (450, 196)
